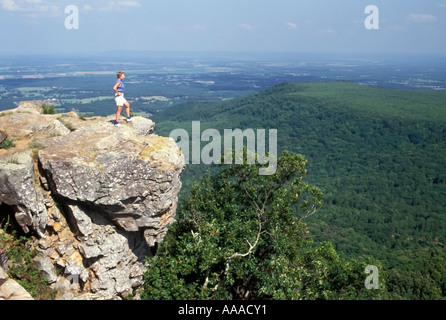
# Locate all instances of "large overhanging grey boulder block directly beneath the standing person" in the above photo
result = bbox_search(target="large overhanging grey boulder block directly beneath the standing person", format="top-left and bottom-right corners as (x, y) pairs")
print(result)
(39, 114), (184, 246)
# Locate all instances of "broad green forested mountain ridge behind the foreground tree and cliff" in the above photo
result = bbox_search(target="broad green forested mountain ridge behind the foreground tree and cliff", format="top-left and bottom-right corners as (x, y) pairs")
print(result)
(153, 81), (446, 299)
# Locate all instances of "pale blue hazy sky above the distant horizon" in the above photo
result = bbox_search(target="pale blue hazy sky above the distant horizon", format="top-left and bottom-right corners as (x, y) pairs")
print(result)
(0, 0), (446, 54)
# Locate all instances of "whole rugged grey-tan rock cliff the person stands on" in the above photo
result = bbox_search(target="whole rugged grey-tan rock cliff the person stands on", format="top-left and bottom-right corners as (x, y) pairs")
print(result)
(0, 104), (184, 298)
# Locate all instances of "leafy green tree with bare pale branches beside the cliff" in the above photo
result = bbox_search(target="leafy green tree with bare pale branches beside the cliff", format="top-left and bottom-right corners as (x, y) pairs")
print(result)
(142, 151), (385, 300)
